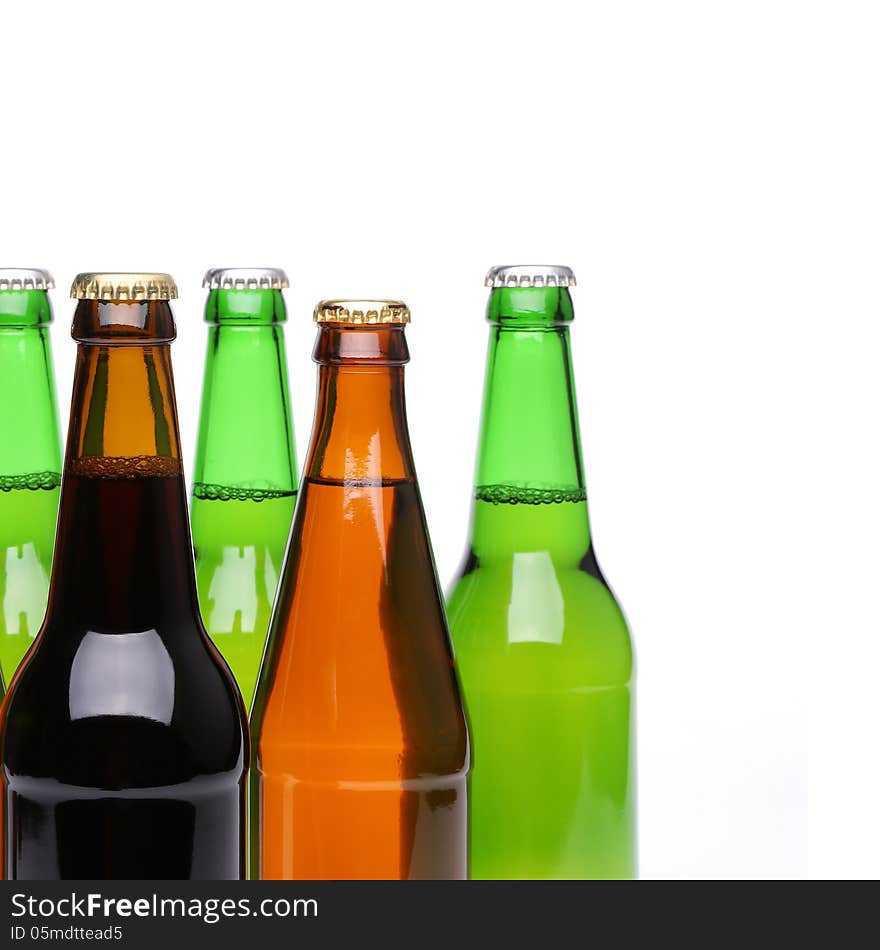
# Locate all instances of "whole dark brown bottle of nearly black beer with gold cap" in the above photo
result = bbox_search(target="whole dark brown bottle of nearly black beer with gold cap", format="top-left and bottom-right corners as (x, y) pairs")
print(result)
(0, 274), (249, 879)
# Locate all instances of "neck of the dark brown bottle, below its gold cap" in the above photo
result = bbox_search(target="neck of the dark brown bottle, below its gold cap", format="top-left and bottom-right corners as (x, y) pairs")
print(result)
(49, 301), (197, 633)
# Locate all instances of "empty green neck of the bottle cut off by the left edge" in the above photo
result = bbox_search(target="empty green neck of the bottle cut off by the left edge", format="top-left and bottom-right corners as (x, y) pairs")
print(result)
(0, 290), (61, 490)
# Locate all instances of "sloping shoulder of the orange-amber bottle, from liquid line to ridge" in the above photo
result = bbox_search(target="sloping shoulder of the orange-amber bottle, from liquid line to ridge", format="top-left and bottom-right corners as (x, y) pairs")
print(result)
(251, 479), (467, 779)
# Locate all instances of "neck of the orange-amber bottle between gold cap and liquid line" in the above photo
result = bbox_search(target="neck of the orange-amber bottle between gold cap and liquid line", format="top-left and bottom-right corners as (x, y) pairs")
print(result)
(305, 327), (415, 485)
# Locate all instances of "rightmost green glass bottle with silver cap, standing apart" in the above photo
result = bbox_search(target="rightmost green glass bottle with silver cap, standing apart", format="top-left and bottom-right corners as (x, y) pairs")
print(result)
(448, 266), (636, 879)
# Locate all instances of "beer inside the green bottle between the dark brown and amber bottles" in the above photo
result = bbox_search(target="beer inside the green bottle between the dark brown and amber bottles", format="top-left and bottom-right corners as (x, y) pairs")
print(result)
(192, 482), (296, 708)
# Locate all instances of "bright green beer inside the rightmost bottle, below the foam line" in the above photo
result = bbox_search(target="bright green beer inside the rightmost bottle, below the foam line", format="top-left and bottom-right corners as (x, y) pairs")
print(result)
(448, 485), (636, 879)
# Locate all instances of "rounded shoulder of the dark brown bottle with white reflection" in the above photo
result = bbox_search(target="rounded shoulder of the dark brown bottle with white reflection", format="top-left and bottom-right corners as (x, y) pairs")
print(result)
(2, 625), (248, 787)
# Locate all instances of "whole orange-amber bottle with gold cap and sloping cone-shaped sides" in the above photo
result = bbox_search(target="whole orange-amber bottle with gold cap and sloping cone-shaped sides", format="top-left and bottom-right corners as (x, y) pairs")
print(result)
(251, 300), (469, 879)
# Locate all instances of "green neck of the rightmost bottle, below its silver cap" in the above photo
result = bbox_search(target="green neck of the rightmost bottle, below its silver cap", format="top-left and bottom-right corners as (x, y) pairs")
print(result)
(472, 288), (590, 559)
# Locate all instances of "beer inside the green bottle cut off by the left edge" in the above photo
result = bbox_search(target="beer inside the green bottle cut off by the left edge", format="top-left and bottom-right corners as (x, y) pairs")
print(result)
(0, 472), (61, 685)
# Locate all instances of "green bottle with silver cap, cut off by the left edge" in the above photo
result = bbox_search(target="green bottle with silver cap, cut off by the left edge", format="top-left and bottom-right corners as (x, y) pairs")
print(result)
(0, 268), (61, 689)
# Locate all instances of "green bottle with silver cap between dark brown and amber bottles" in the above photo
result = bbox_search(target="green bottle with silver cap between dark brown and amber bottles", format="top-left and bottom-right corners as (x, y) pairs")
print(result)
(192, 268), (297, 708)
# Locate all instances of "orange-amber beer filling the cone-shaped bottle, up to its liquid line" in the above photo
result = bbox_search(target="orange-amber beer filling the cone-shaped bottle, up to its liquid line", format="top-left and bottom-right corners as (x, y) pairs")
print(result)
(252, 477), (467, 879)
